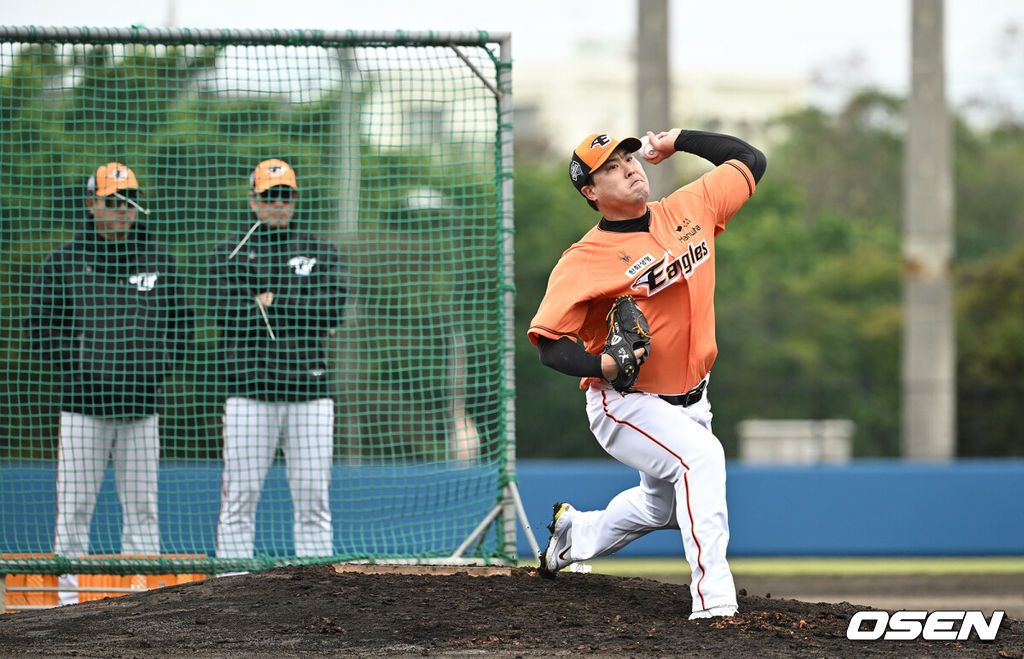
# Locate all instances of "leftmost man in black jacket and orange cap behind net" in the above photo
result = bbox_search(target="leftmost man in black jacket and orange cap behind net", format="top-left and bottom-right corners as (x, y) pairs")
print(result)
(27, 163), (194, 604)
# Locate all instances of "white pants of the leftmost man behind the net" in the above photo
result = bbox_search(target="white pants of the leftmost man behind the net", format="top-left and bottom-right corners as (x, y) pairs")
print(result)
(53, 411), (160, 604)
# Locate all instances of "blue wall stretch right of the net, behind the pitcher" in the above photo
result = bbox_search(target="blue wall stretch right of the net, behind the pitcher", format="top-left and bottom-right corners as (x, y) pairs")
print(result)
(516, 459), (1024, 557)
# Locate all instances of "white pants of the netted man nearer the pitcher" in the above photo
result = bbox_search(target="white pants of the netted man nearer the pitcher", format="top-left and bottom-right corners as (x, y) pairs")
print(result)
(217, 397), (334, 559)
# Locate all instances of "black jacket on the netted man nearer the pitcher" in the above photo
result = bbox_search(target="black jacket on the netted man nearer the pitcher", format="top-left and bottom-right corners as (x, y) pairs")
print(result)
(210, 225), (346, 402)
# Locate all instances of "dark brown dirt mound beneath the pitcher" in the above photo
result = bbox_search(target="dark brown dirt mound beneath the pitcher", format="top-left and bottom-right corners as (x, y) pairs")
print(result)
(0, 565), (1024, 659)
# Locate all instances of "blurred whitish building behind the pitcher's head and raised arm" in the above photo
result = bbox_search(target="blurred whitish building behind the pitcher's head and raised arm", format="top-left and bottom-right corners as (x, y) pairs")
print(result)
(512, 42), (809, 152)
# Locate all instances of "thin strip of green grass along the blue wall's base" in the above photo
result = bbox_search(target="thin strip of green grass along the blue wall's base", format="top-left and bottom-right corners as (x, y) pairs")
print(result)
(519, 556), (1024, 577)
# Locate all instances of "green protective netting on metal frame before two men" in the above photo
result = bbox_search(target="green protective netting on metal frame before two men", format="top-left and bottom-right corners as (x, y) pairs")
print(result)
(0, 28), (515, 574)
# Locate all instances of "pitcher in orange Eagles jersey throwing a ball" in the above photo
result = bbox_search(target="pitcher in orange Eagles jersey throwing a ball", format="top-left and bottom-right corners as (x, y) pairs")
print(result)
(528, 129), (766, 619)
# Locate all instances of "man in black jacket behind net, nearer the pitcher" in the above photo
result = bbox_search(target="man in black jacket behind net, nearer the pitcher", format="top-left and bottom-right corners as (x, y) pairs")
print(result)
(210, 159), (346, 558)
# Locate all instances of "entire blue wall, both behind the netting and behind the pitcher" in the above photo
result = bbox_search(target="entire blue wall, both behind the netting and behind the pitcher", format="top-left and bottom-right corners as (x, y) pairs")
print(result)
(0, 459), (1024, 558)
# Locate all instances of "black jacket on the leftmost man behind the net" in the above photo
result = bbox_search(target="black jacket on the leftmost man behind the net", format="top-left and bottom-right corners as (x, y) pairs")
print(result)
(27, 222), (195, 419)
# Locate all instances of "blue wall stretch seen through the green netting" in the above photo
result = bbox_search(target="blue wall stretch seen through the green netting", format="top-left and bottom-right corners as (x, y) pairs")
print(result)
(0, 459), (501, 557)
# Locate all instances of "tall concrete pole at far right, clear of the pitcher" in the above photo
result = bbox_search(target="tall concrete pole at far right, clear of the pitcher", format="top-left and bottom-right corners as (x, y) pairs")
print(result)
(901, 0), (956, 459)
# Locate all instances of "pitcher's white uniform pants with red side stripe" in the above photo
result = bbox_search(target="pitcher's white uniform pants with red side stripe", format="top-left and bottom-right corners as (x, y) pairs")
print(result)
(570, 386), (736, 611)
